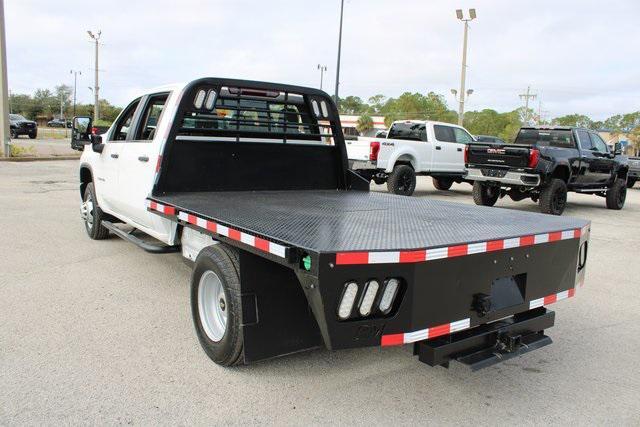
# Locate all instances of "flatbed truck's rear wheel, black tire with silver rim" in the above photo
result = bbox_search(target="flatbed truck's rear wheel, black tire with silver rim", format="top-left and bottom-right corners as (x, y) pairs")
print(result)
(191, 243), (244, 366)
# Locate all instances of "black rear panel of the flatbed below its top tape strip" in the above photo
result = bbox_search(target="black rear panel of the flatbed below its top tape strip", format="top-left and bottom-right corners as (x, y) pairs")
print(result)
(320, 234), (584, 349)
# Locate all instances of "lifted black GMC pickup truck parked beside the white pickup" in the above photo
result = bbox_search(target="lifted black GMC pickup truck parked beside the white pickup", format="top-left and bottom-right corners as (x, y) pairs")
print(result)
(465, 127), (629, 215)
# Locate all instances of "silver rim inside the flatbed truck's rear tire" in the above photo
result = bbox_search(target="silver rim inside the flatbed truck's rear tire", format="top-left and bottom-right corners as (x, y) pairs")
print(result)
(198, 270), (229, 342)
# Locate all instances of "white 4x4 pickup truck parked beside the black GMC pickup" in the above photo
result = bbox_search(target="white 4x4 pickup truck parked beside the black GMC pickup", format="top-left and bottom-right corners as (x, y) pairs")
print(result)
(346, 120), (474, 196)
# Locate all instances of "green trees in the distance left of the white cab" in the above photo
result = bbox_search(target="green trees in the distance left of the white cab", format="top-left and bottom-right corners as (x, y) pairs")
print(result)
(9, 85), (122, 125)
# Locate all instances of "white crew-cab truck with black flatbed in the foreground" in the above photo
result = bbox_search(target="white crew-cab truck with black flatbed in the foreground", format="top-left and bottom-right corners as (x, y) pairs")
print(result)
(73, 78), (589, 369)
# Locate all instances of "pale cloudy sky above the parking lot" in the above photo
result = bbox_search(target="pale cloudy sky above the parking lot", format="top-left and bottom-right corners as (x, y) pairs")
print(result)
(5, 0), (640, 120)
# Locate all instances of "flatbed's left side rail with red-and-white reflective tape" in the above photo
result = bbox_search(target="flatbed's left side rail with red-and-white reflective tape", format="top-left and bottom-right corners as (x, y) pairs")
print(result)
(147, 199), (294, 265)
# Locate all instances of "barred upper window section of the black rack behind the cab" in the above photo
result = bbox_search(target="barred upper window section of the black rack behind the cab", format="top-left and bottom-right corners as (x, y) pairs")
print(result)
(176, 79), (340, 145)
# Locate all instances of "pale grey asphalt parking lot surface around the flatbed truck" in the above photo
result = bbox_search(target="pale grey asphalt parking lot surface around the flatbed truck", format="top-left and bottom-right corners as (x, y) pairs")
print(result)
(0, 161), (640, 425)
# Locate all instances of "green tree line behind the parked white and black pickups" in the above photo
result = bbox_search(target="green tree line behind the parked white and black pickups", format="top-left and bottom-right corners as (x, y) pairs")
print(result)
(339, 92), (640, 143)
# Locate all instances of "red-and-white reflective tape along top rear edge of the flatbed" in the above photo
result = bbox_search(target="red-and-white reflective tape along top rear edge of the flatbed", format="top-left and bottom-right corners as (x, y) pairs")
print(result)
(336, 229), (582, 265)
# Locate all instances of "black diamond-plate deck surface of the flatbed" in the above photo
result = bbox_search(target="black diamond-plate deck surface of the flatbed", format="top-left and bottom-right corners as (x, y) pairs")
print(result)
(151, 190), (588, 253)
